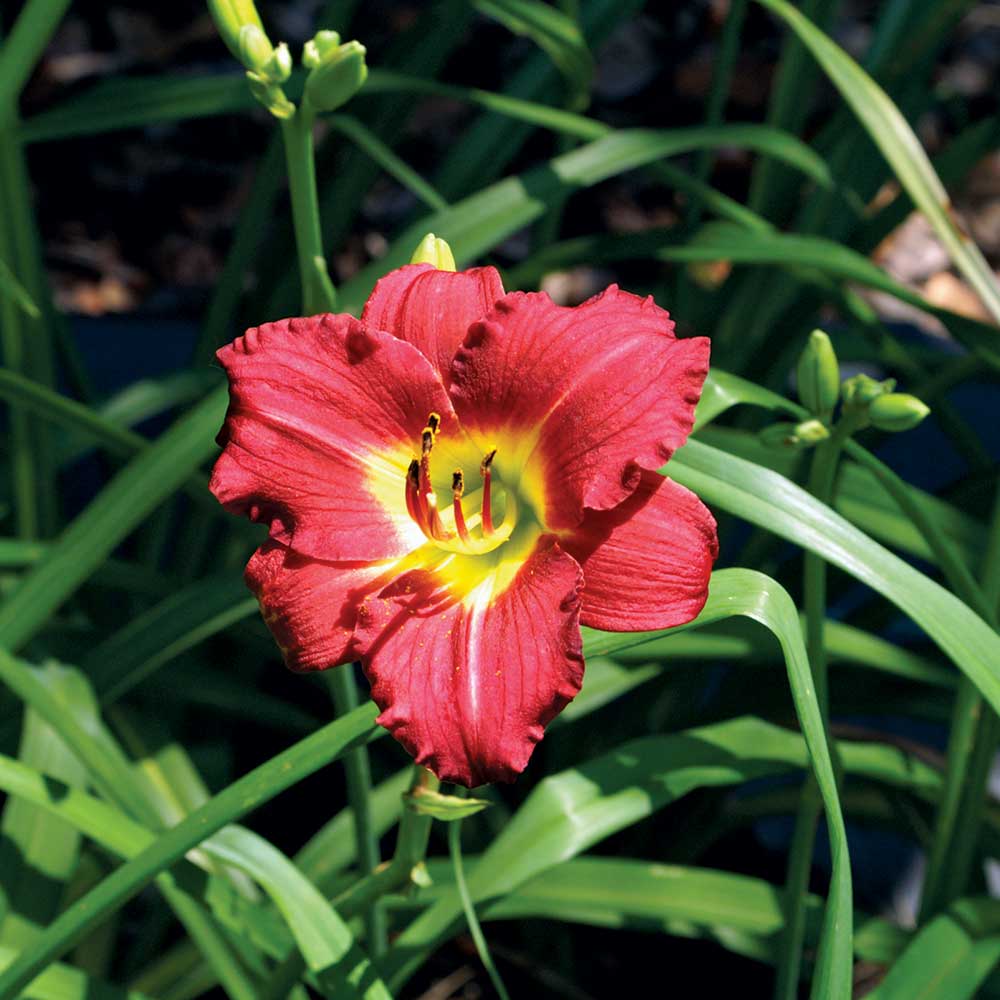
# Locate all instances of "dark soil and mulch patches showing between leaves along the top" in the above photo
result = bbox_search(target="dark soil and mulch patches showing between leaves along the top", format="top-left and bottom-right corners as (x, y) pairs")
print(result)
(8, 0), (1000, 322)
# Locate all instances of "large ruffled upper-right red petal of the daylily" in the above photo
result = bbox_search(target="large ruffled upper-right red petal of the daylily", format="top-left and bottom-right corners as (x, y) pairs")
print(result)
(449, 285), (709, 529)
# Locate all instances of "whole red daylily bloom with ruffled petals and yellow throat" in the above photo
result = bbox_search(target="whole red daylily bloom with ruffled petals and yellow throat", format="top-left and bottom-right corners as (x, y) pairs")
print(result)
(211, 256), (717, 786)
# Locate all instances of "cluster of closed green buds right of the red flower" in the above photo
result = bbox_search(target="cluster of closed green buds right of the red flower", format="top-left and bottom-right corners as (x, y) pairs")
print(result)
(761, 330), (930, 449)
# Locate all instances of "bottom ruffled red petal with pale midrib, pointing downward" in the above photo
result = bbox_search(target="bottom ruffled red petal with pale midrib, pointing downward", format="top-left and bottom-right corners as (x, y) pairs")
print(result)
(355, 536), (583, 787)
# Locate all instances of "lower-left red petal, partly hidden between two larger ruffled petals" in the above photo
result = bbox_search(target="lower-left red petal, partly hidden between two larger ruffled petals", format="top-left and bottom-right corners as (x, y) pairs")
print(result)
(244, 541), (398, 670)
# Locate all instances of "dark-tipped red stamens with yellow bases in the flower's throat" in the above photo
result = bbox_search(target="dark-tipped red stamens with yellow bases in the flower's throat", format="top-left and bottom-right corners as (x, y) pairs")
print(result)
(406, 413), (517, 555)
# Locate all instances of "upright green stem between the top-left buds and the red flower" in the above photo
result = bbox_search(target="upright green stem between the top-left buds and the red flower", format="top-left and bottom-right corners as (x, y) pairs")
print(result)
(281, 99), (337, 316)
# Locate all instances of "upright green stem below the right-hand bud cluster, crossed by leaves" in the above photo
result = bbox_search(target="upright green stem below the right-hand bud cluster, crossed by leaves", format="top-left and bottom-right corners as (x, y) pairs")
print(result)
(774, 415), (857, 1000)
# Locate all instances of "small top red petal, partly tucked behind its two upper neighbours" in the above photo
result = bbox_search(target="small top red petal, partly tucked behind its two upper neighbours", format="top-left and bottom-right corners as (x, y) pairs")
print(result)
(361, 264), (504, 385)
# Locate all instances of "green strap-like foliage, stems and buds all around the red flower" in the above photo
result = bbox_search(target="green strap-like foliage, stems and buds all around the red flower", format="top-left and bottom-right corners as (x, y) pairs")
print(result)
(0, 0), (1000, 1000)
